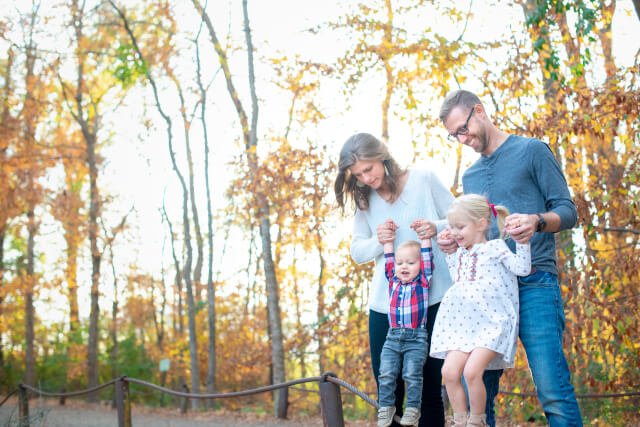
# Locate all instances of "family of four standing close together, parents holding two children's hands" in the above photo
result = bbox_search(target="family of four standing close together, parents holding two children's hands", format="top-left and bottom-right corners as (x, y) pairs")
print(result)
(335, 90), (582, 427)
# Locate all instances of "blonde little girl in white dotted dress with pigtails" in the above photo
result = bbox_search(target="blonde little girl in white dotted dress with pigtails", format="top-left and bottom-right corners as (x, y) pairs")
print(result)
(431, 194), (531, 427)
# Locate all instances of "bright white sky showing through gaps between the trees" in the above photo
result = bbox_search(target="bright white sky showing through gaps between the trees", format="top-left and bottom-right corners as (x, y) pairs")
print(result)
(0, 0), (640, 324)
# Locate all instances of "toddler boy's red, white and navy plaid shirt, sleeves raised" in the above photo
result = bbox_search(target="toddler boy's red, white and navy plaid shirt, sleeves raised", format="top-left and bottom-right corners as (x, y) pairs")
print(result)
(384, 248), (433, 329)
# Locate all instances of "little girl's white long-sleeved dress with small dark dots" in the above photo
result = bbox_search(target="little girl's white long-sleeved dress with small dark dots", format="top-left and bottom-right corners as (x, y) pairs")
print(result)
(430, 239), (531, 369)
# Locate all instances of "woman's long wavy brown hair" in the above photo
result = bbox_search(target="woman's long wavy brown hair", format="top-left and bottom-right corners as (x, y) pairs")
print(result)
(333, 133), (405, 213)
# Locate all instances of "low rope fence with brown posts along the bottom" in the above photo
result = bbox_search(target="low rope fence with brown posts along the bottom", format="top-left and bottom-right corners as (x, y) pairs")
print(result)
(0, 372), (640, 427)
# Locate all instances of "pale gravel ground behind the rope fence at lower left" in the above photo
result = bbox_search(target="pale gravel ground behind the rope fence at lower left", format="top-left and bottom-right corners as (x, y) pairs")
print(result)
(0, 399), (375, 427)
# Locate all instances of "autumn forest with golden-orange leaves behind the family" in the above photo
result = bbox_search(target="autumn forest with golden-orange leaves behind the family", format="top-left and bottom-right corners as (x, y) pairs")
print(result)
(0, 0), (640, 425)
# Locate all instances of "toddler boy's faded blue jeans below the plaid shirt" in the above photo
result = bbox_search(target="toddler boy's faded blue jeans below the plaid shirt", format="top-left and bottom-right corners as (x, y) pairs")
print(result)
(378, 328), (429, 408)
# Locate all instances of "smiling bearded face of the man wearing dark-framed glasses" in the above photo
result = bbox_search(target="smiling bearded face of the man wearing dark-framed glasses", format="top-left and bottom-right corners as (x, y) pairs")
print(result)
(443, 105), (488, 154)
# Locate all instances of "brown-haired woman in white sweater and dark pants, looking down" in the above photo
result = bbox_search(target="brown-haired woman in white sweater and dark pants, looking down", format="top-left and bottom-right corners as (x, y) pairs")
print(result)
(334, 133), (453, 426)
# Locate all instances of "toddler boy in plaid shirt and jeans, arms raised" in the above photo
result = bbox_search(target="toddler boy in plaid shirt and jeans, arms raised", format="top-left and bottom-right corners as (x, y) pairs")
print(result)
(378, 222), (433, 427)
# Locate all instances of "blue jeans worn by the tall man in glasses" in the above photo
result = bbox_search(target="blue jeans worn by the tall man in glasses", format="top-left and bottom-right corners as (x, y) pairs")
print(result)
(484, 271), (582, 427)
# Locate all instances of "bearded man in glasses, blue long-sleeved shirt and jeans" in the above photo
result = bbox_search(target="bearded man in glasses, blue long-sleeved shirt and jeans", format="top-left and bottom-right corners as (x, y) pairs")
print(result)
(438, 90), (582, 427)
